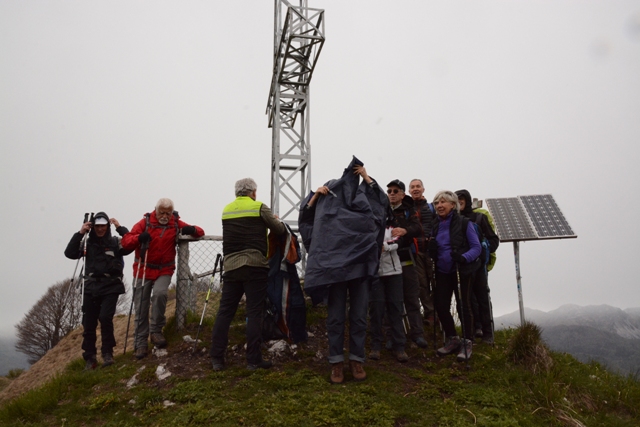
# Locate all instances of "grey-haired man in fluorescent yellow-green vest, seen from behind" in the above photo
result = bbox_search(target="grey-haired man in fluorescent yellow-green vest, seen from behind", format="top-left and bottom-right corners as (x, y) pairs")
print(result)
(210, 178), (286, 371)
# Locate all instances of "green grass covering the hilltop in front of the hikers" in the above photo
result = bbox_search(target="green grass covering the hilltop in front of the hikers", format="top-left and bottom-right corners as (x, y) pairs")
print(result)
(0, 309), (640, 427)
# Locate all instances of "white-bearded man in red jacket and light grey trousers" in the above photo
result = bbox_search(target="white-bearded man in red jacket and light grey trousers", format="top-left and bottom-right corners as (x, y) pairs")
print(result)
(122, 198), (204, 359)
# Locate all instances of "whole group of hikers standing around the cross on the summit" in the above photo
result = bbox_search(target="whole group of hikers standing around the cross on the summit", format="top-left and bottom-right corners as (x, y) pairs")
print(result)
(65, 157), (499, 384)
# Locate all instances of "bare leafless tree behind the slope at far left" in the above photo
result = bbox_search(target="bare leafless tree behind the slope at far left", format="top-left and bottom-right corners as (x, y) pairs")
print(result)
(15, 279), (82, 364)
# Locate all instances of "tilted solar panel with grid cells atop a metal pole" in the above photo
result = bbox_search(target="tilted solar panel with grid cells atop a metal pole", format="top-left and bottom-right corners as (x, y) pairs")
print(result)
(487, 194), (578, 242)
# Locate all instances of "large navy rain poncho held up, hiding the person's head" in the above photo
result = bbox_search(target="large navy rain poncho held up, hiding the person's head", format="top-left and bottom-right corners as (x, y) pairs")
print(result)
(298, 157), (389, 303)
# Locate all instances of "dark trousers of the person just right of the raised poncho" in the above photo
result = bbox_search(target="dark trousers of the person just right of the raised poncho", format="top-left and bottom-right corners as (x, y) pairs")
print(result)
(369, 274), (407, 351)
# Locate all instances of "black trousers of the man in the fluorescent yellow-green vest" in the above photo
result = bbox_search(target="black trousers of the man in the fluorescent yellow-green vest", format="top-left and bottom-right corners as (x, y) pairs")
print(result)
(210, 266), (269, 365)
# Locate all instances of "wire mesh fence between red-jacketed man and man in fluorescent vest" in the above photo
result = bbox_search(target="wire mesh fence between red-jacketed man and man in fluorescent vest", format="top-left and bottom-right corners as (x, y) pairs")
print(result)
(176, 236), (222, 329)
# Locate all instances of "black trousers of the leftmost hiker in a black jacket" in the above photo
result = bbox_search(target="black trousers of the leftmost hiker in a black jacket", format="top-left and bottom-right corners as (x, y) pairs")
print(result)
(82, 292), (119, 360)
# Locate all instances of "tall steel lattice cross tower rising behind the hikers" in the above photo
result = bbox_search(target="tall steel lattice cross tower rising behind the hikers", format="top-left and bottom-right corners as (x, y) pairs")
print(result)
(267, 0), (324, 231)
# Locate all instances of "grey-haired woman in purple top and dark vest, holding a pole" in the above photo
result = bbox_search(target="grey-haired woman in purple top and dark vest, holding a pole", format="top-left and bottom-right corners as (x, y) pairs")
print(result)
(429, 191), (482, 362)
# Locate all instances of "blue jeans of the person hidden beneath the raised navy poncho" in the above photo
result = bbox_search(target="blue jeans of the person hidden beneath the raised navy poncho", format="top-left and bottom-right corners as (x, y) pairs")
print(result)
(327, 278), (371, 363)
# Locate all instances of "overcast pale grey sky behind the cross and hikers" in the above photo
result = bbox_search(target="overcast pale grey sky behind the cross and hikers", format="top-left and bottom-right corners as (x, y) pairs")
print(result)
(0, 0), (640, 338)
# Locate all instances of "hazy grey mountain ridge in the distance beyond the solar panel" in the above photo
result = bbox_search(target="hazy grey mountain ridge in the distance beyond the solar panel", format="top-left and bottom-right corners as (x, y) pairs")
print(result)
(494, 304), (640, 374)
